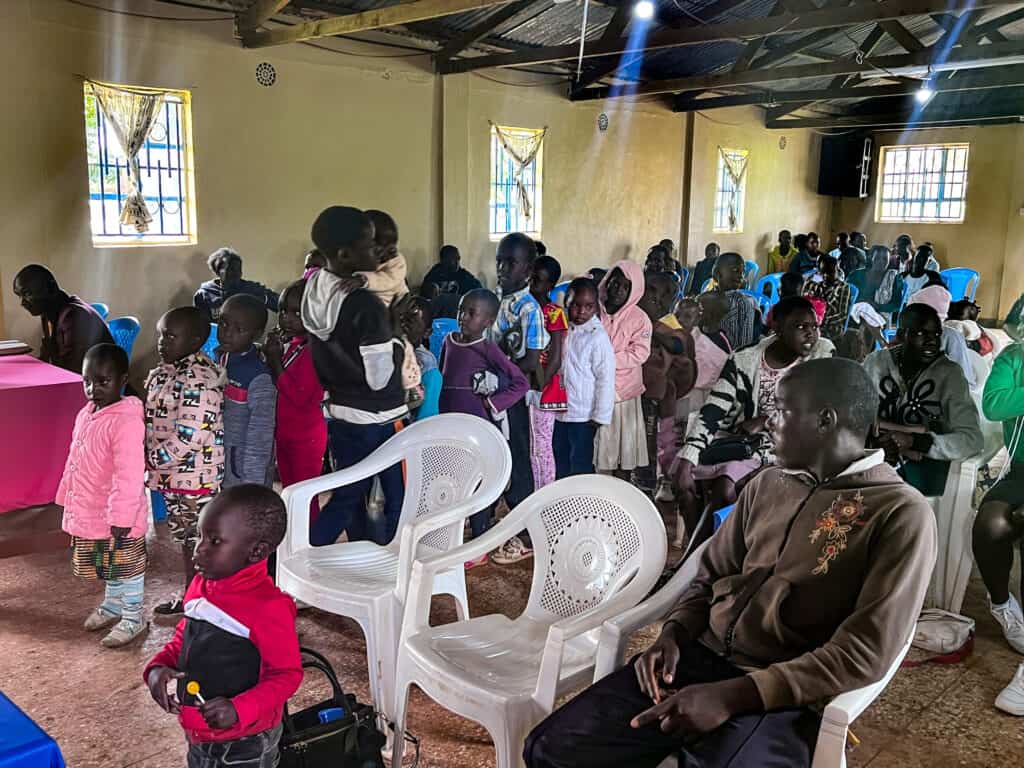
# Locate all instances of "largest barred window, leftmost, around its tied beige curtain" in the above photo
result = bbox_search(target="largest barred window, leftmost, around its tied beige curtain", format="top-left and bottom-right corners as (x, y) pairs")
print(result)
(85, 83), (197, 247)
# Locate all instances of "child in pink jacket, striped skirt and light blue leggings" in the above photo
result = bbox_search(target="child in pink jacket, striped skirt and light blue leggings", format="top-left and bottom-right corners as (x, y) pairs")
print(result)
(57, 344), (148, 648)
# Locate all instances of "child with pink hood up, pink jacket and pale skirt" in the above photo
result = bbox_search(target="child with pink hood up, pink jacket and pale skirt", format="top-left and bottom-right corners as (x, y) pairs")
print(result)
(594, 261), (651, 477)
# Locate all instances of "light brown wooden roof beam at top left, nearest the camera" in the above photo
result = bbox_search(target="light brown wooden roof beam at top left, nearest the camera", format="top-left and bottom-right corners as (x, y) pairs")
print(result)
(242, 0), (520, 48)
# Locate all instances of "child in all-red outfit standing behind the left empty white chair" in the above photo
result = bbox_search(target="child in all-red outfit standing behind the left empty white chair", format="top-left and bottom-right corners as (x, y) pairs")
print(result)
(263, 280), (327, 524)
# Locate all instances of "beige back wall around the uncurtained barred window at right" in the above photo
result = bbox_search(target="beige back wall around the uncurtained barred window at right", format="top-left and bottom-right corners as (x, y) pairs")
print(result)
(834, 125), (1024, 318)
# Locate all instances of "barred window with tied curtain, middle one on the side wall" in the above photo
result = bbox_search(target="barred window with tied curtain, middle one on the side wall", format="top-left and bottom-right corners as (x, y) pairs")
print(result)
(489, 126), (544, 240)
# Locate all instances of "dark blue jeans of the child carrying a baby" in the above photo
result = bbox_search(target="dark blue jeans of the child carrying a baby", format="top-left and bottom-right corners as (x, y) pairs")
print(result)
(309, 419), (406, 547)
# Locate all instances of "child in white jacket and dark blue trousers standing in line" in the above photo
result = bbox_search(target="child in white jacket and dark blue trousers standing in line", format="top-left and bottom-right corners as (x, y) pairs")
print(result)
(552, 278), (615, 479)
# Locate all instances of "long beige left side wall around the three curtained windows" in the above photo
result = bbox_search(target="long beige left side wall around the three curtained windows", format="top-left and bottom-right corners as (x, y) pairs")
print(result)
(0, 0), (828, 377)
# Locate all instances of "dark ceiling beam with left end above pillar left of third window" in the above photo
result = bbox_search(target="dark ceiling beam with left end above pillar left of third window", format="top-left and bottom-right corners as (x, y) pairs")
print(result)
(673, 65), (1024, 111)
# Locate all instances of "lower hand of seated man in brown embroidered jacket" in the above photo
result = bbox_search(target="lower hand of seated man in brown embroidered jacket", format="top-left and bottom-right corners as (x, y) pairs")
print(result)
(630, 675), (764, 735)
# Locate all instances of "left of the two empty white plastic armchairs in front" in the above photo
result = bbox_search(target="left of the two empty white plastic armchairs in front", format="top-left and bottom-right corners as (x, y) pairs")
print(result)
(278, 414), (512, 729)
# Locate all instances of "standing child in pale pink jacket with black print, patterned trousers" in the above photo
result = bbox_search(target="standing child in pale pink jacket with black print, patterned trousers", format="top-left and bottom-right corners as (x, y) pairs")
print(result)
(145, 309), (222, 616)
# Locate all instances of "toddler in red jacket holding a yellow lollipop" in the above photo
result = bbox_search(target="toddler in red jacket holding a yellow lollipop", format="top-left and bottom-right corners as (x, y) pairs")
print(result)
(143, 483), (302, 768)
